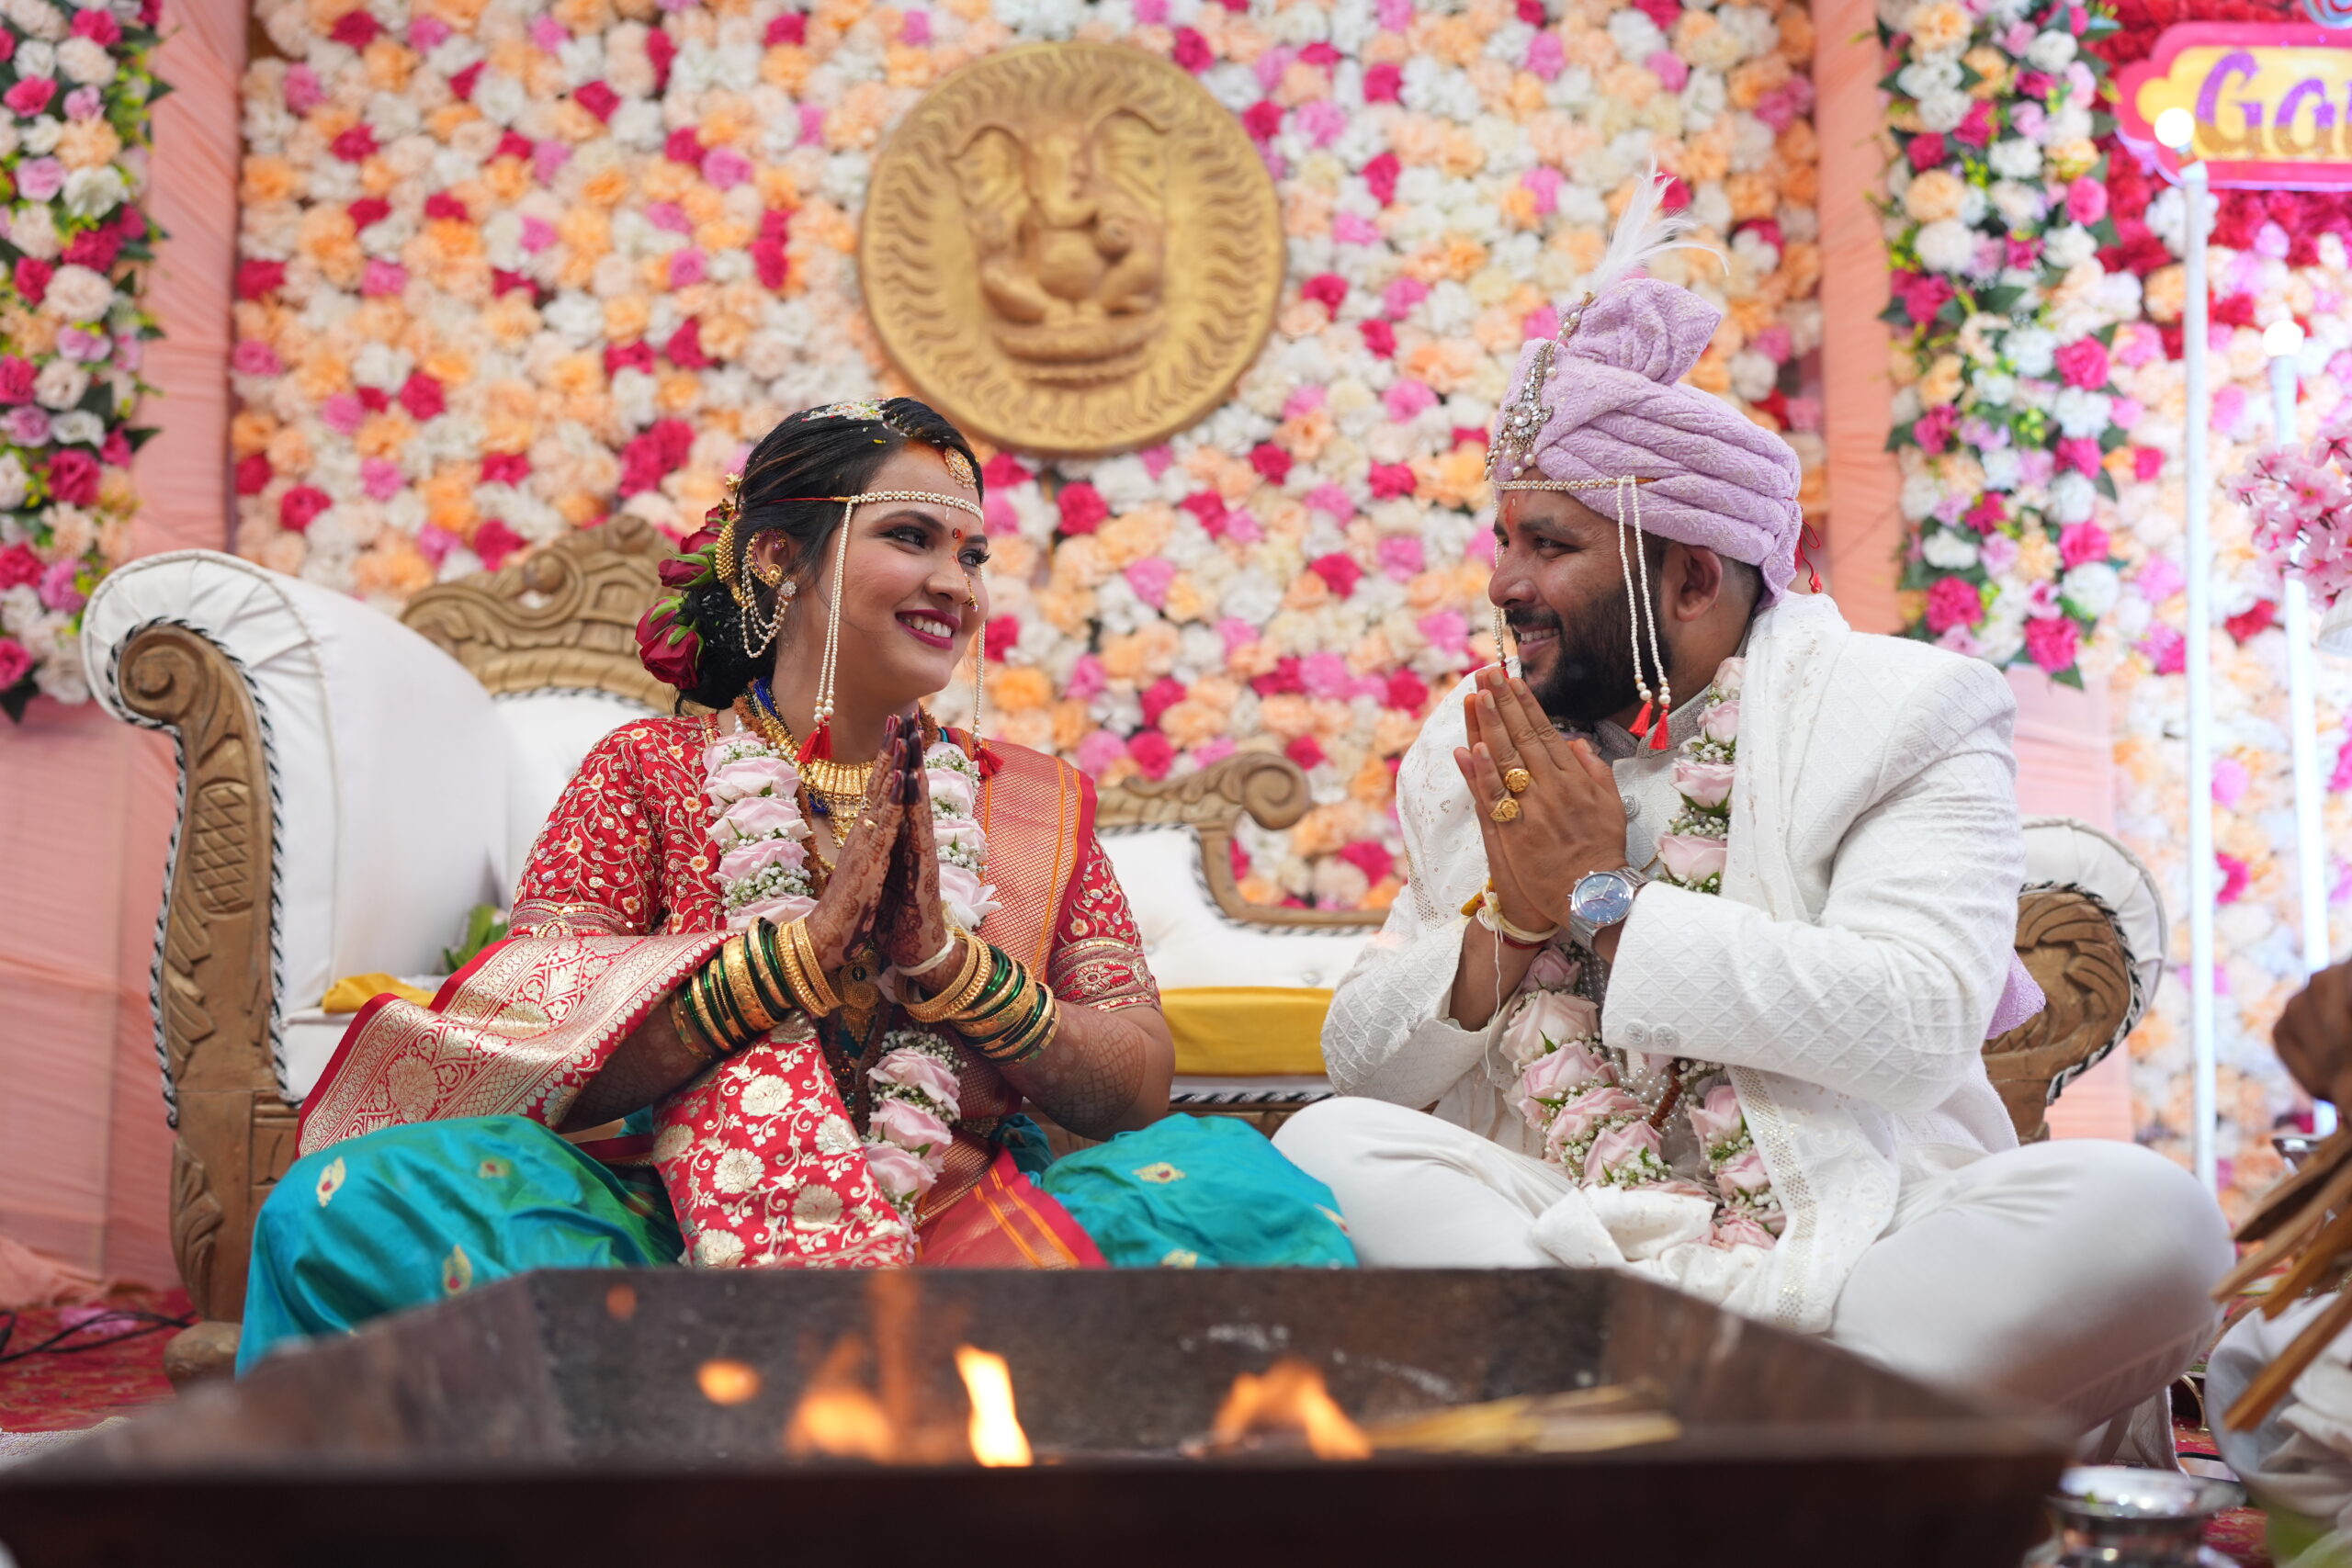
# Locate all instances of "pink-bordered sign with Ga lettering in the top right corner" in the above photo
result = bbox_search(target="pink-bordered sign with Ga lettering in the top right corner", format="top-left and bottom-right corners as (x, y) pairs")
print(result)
(2114, 21), (2352, 190)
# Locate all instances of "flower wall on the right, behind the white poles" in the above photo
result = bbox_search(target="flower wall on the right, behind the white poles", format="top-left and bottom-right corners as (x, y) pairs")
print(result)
(1879, 0), (2352, 1201)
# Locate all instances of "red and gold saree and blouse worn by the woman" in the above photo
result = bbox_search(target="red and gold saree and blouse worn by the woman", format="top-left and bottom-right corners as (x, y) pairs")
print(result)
(301, 719), (1158, 1267)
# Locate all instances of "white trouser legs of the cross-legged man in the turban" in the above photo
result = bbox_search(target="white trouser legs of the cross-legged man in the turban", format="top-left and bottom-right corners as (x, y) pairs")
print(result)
(1275, 1098), (2232, 1429)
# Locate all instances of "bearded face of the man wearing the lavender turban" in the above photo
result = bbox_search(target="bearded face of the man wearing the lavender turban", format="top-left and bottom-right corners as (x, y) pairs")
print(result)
(1487, 489), (1675, 724)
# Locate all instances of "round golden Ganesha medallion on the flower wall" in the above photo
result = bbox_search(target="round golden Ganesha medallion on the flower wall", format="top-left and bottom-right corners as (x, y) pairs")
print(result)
(858, 45), (1282, 454)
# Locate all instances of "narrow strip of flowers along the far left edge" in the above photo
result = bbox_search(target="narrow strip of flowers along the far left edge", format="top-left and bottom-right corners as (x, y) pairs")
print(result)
(0, 0), (163, 719)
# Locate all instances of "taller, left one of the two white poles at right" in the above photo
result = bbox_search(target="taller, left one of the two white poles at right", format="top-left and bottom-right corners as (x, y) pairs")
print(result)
(2180, 136), (2221, 1187)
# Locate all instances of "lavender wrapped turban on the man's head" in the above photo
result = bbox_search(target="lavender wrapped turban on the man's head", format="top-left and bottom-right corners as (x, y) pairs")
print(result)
(1494, 277), (1804, 604)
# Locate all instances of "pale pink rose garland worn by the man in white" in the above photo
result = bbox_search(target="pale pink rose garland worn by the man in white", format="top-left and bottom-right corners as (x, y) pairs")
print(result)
(1503, 659), (1785, 1248)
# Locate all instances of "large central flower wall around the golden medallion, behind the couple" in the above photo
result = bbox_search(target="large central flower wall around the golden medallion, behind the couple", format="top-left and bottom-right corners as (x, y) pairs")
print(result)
(232, 0), (1823, 908)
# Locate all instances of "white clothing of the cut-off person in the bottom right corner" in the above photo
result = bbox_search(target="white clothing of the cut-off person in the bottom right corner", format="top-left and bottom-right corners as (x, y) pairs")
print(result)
(2206, 1295), (2352, 1563)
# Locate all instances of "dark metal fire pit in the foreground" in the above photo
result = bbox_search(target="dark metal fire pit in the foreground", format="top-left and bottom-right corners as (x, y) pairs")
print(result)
(0, 1269), (2063, 1568)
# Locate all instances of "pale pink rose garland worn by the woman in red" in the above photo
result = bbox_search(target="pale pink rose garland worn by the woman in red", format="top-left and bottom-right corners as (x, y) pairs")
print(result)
(703, 733), (997, 1215)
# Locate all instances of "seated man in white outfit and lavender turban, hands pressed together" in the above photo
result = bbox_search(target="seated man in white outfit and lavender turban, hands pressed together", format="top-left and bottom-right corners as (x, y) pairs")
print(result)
(1277, 199), (2230, 1462)
